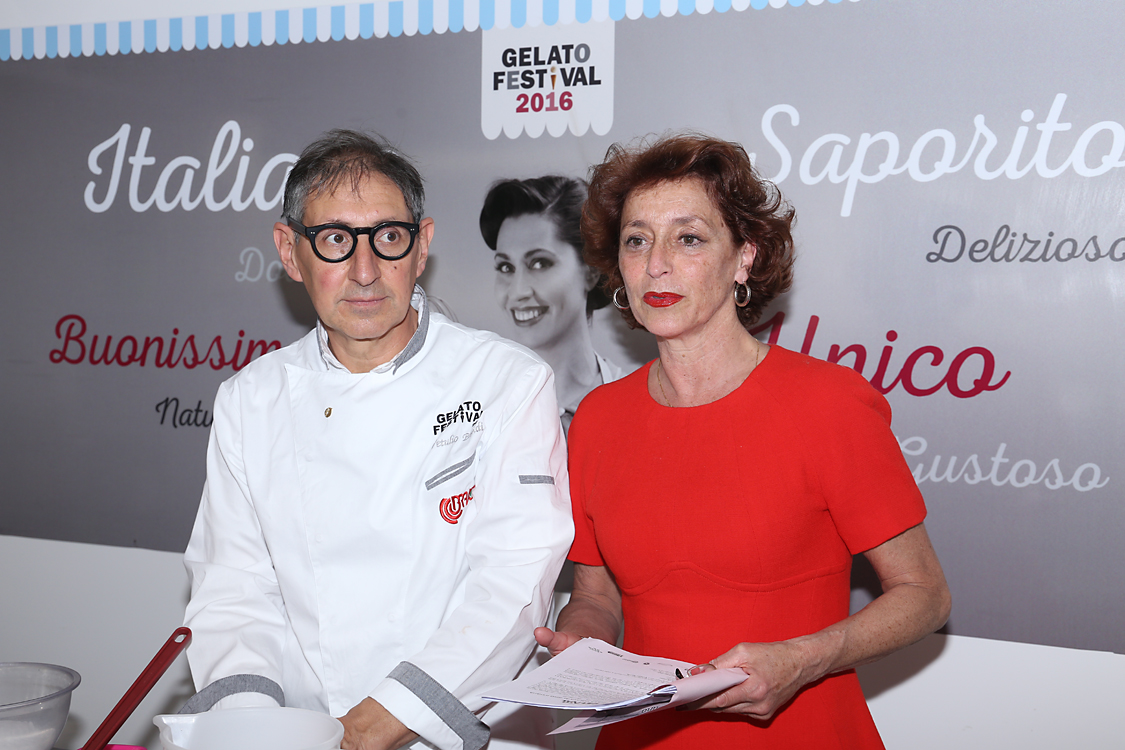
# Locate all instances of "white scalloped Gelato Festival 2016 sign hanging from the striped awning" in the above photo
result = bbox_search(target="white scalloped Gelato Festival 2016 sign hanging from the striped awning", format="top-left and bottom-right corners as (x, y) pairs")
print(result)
(480, 21), (614, 138)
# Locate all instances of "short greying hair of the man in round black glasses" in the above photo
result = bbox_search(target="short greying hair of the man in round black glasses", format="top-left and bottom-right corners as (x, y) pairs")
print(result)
(281, 129), (425, 224)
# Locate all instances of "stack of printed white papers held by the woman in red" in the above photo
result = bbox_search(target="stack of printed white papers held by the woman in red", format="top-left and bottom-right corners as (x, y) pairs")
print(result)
(482, 638), (746, 734)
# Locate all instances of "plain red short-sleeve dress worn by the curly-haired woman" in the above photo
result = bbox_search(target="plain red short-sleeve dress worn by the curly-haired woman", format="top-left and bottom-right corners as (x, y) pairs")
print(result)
(569, 346), (926, 750)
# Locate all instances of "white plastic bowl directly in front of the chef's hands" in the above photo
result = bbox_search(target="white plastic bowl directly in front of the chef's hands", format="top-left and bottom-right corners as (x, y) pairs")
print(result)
(155, 708), (344, 750)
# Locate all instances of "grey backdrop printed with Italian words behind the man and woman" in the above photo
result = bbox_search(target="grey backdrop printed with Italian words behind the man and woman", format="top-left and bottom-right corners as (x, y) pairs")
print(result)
(0, 0), (1125, 746)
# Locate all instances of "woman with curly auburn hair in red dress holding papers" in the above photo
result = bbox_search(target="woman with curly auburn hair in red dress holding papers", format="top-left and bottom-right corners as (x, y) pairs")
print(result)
(536, 135), (950, 750)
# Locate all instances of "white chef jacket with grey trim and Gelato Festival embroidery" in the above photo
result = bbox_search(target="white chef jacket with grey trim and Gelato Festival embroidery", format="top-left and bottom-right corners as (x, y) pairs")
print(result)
(185, 287), (574, 750)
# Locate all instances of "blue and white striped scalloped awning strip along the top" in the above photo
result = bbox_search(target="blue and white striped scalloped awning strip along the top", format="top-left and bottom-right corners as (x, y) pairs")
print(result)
(0, 0), (858, 61)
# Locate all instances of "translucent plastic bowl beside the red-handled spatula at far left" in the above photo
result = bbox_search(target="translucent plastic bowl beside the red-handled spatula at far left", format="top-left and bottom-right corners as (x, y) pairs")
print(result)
(0, 661), (82, 750)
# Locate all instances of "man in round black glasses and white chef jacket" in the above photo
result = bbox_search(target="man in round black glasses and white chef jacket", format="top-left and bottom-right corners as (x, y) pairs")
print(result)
(185, 130), (573, 750)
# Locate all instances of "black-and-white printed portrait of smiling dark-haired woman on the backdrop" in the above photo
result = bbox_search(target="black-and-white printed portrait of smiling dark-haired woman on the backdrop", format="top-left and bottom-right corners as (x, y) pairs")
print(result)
(480, 175), (623, 430)
